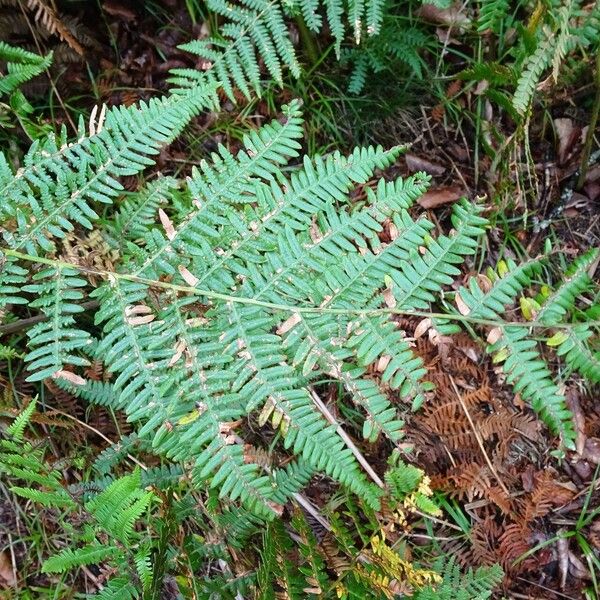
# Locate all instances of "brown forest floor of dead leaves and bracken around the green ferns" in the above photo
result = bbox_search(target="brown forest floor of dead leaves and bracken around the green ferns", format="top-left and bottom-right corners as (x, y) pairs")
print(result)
(0, 0), (600, 600)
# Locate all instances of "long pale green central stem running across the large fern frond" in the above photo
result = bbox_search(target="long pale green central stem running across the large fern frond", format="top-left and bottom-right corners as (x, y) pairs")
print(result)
(0, 248), (600, 329)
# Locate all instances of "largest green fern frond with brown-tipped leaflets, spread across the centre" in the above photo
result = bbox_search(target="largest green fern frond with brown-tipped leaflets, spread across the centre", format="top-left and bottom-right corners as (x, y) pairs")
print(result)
(0, 87), (597, 519)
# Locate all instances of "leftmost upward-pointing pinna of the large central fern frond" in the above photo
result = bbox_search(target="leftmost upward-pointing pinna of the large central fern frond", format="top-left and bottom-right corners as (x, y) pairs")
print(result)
(0, 87), (213, 254)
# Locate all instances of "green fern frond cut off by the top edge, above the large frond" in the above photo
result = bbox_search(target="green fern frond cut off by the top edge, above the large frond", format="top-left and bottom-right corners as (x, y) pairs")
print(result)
(171, 0), (390, 100)
